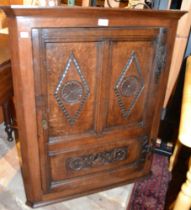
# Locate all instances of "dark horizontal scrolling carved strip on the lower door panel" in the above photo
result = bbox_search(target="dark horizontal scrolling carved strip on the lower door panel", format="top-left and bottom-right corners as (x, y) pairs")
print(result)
(67, 147), (128, 171)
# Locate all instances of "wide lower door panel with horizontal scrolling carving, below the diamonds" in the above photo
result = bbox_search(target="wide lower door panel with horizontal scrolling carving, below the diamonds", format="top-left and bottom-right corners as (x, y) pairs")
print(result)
(49, 137), (145, 181)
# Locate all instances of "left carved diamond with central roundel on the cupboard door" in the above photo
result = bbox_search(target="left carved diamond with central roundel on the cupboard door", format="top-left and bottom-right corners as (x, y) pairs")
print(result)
(54, 53), (90, 125)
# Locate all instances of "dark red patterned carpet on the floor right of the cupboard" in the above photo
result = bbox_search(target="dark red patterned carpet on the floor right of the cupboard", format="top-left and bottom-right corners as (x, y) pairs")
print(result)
(127, 154), (171, 210)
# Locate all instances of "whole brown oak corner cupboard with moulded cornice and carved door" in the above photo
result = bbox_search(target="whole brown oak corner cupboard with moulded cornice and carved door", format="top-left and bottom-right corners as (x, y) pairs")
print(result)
(1, 6), (184, 207)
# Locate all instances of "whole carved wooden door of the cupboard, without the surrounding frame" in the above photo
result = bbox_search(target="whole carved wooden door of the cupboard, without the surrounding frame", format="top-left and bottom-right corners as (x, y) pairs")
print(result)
(32, 27), (165, 196)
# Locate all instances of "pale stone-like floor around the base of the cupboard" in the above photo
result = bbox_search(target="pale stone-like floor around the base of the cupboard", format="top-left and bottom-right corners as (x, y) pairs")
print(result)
(0, 124), (133, 210)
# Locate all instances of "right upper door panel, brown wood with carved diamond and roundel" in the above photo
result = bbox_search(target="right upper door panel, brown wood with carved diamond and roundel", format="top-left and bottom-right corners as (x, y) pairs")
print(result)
(107, 41), (155, 128)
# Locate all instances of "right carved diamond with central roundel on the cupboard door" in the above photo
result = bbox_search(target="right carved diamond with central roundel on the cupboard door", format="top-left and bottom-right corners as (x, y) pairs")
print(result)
(114, 51), (144, 119)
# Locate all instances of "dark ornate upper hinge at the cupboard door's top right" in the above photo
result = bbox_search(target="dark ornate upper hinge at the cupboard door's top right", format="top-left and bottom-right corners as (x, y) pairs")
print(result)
(155, 28), (167, 82)
